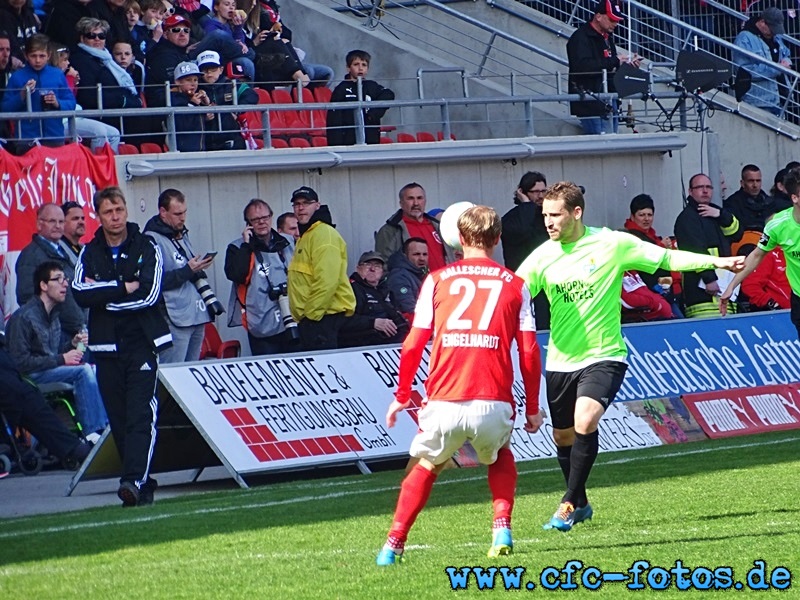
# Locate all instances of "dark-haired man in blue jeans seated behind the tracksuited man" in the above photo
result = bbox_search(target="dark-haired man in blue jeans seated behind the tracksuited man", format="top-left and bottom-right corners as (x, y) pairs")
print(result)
(8, 261), (108, 442)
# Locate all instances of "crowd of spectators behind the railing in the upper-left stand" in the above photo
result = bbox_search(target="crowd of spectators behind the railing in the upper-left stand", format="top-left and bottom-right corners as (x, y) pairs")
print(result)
(0, 0), (394, 154)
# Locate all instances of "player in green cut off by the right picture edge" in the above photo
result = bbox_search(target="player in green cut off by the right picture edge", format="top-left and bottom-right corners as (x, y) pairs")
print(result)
(719, 168), (800, 337)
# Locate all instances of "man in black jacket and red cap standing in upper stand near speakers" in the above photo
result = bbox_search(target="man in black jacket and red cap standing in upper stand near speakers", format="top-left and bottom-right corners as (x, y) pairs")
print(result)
(567, 0), (640, 134)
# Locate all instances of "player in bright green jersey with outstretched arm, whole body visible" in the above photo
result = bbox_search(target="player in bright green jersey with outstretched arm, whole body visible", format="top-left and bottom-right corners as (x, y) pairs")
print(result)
(517, 182), (744, 531)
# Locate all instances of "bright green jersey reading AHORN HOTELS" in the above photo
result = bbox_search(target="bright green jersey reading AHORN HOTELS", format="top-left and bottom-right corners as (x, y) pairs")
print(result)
(517, 227), (713, 372)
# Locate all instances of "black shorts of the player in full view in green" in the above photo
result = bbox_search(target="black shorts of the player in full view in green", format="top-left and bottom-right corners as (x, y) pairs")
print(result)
(545, 360), (628, 429)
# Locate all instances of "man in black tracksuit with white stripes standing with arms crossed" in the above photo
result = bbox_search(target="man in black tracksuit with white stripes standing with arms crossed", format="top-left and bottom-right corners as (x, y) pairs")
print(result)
(72, 187), (172, 506)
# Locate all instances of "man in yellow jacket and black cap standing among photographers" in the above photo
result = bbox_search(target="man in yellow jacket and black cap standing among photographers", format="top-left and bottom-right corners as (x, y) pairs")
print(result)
(289, 186), (356, 350)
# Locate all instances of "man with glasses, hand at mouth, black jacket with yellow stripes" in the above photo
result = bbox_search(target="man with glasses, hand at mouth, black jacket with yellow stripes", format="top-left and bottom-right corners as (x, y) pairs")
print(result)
(675, 173), (739, 317)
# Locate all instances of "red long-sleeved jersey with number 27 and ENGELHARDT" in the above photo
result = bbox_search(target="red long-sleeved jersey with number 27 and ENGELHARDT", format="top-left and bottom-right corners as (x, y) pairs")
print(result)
(396, 258), (541, 414)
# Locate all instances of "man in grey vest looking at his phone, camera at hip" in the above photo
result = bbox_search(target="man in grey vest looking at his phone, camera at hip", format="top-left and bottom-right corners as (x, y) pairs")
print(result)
(144, 188), (214, 363)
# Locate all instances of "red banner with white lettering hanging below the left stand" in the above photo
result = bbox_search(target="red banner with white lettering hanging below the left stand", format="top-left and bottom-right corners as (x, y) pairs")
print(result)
(0, 144), (117, 320)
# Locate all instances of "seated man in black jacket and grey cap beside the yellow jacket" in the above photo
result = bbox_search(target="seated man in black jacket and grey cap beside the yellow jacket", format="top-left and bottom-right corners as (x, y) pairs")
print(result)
(339, 252), (409, 348)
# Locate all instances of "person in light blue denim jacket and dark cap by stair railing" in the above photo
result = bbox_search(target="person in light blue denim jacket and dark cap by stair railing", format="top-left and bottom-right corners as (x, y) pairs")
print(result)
(733, 6), (792, 115)
